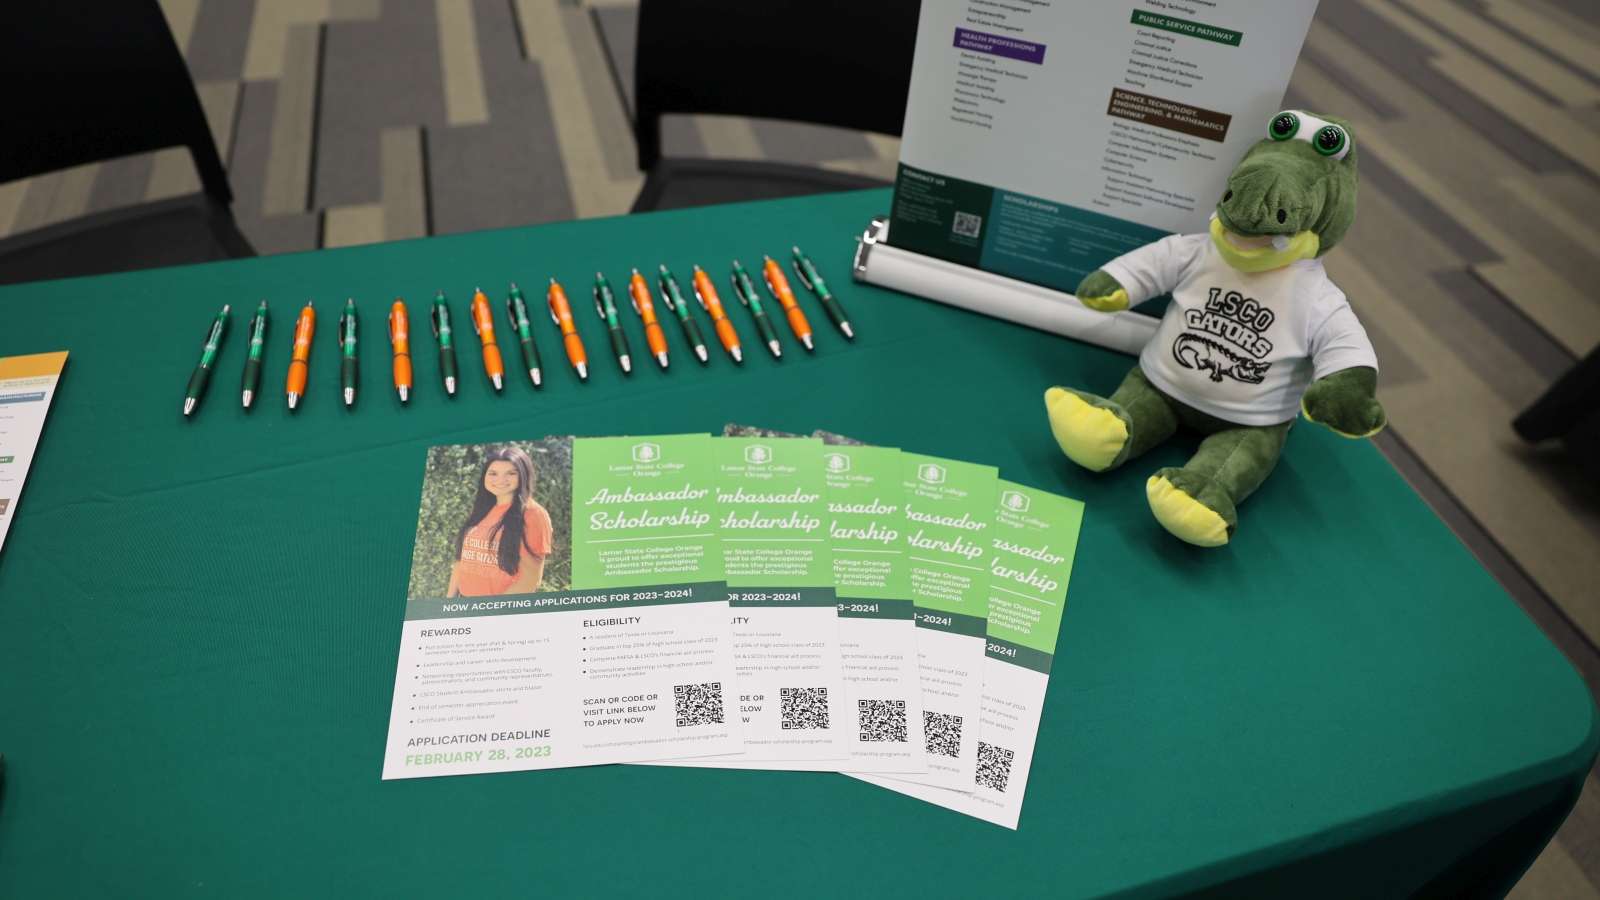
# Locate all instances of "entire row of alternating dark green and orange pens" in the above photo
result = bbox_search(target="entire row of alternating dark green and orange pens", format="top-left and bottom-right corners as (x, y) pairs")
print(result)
(184, 247), (854, 416)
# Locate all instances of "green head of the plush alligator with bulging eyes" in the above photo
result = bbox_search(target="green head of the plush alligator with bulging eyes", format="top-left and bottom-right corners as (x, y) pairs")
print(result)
(1211, 109), (1355, 272)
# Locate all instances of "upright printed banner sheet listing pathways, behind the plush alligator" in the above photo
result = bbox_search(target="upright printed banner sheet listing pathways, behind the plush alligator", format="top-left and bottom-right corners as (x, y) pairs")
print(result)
(888, 0), (1317, 293)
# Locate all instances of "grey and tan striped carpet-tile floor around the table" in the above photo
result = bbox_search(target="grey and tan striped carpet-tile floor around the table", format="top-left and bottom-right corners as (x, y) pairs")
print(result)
(0, 0), (1600, 900)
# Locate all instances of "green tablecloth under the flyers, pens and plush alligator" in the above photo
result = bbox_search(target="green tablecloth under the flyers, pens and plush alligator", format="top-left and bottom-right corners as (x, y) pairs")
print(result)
(0, 191), (1600, 900)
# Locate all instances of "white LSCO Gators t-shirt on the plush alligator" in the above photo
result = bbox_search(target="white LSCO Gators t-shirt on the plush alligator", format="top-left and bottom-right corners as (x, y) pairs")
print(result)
(1104, 234), (1378, 424)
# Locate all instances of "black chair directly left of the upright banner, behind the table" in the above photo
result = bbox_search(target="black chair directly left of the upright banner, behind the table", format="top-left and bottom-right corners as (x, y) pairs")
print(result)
(634, 0), (920, 213)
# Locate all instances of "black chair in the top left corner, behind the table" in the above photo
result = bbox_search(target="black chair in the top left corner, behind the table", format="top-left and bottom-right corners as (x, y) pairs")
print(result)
(0, 0), (256, 283)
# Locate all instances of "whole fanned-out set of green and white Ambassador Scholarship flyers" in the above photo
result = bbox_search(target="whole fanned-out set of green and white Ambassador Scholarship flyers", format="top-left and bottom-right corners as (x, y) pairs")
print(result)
(384, 426), (1083, 828)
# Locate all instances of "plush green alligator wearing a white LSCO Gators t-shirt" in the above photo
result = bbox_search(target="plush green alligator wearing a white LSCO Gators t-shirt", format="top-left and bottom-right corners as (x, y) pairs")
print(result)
(1045, 110), (1386, 546)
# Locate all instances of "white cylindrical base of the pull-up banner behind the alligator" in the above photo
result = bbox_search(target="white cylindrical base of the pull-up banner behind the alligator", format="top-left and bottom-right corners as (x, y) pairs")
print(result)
(856, 223), (1160, 356)
